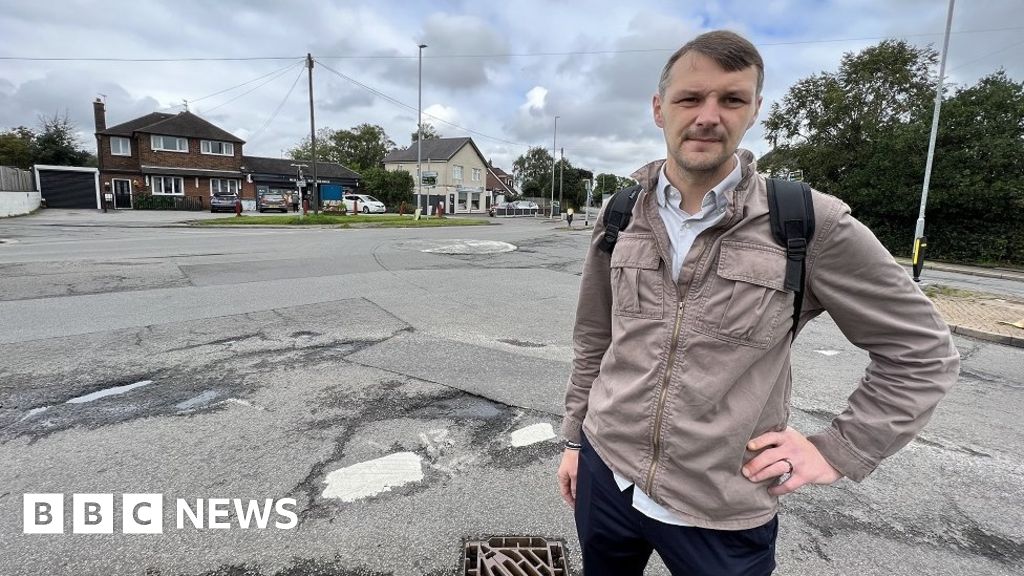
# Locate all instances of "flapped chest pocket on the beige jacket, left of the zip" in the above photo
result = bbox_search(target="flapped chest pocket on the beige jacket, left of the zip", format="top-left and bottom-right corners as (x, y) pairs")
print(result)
(610, 234), (665, 320)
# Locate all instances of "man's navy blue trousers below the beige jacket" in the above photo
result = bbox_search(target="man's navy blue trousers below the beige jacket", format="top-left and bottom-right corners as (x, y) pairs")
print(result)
(575, 438), (778, 576)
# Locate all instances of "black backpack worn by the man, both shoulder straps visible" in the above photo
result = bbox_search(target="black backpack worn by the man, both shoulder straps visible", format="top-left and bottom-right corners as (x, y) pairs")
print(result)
(599, 178), (814, 334)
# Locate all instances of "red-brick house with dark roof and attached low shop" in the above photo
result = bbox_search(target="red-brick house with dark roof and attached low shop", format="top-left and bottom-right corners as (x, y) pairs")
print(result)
(92, 98), (359, 210)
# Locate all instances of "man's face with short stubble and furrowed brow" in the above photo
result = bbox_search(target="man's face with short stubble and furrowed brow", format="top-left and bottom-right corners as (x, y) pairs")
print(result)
(653, 52), (761, 177)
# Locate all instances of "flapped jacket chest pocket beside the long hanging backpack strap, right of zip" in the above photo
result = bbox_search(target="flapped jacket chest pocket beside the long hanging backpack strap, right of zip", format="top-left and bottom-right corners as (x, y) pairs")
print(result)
(695, 241), (794, 348)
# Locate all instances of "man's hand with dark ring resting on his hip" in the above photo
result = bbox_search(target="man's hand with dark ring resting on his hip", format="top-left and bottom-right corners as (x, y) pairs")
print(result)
(745, 427), (843, 496)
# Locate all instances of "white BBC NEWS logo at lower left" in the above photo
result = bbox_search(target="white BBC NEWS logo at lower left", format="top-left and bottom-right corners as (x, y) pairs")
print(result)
(24, 494), (299, 534)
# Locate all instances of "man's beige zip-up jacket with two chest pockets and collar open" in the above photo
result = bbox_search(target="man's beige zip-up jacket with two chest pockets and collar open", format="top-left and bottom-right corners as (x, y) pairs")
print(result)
(562, 151), (959, 530)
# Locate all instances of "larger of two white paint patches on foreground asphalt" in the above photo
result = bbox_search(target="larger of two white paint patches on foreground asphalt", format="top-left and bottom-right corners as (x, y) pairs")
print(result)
(321, 452), (423, 502)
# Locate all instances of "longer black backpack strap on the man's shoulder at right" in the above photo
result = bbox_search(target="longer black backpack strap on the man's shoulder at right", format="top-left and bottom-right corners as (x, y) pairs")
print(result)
(767, 178), (814, 337)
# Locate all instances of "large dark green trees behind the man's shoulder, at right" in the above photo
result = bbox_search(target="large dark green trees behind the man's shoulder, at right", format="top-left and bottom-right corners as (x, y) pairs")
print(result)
(758, 40), (1024, 263)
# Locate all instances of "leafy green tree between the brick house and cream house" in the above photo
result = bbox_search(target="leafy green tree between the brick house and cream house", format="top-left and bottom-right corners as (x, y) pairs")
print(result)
(289, 124), (394, 172)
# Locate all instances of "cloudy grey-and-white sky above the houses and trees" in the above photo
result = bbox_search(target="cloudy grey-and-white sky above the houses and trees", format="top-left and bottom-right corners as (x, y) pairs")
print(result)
(0, 0), (1024, 175)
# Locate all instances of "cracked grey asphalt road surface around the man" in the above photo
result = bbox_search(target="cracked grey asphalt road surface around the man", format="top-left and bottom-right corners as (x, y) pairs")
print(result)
(0, 211), (1024, 576)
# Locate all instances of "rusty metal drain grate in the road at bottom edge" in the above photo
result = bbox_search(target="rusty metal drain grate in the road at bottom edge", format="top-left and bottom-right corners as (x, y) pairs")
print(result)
(462, 536), (568, 576)
